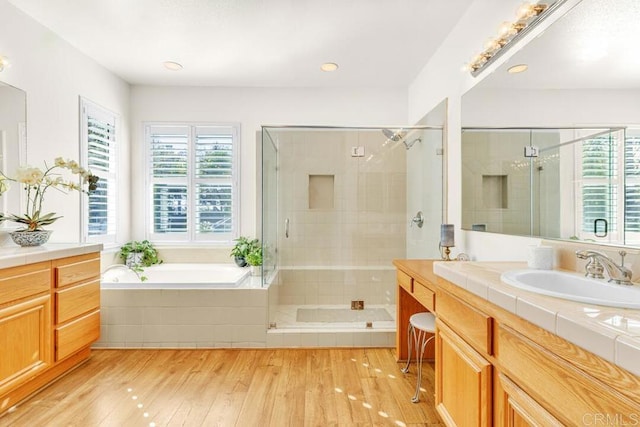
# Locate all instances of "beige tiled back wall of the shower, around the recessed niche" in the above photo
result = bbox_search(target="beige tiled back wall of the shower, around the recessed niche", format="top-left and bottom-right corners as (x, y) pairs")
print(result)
(278, 131), (406, 267)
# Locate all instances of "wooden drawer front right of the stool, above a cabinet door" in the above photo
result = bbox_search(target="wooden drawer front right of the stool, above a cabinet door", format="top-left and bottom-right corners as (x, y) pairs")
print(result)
(438, 292), (492, 354)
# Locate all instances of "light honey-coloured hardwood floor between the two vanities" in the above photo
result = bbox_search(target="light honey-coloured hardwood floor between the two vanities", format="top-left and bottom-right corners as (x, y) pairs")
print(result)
(0, 348), (442, 427)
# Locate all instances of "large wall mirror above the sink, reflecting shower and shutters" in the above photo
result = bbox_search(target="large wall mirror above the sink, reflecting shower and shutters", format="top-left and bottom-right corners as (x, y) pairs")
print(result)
(462, 0), (640, 246)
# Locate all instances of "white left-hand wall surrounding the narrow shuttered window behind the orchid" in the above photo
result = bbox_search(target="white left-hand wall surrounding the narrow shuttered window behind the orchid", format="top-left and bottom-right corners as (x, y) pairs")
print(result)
(0, 0), (129, 242)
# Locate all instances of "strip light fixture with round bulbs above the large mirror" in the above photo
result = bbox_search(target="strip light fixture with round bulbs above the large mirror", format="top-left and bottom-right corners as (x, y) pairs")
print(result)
(465, 0), (567, 77)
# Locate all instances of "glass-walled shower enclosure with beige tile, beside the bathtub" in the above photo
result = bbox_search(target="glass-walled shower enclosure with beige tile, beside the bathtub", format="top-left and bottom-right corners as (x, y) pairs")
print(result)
(262, 126), (442, 345)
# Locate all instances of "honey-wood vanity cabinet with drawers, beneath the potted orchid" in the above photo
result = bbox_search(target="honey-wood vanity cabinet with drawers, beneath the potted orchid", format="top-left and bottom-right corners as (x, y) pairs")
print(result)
(0, 252), (100, 414)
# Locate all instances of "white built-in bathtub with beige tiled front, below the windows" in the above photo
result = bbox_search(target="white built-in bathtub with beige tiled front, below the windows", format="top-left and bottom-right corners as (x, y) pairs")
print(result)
(94, 263), (268, 348)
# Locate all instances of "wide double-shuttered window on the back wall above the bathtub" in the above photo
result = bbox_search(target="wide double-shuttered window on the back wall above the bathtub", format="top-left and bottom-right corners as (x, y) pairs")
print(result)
(145, 124), (239, 242)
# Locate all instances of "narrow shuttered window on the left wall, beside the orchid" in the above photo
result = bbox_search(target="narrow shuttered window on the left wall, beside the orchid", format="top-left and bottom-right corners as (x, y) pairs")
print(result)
(80, 98), (118, 243)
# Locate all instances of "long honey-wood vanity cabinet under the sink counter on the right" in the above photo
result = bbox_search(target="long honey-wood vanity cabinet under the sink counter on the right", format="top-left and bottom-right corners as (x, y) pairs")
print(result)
(394, 260), (640, 427)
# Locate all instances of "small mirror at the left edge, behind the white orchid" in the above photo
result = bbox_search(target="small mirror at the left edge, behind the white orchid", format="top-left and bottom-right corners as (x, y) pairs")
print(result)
(0, 82), (27, 227)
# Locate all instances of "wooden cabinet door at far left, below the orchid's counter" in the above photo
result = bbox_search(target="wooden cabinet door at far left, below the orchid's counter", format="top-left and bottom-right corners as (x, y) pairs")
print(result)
(0, 295), (52, 396)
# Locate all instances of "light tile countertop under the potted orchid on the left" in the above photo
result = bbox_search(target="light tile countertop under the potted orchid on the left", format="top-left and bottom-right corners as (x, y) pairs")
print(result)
(0, 243), (102, 268)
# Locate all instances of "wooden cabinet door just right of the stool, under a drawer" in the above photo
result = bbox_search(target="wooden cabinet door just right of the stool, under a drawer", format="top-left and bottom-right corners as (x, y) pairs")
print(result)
(436, 320), (492, 426)
